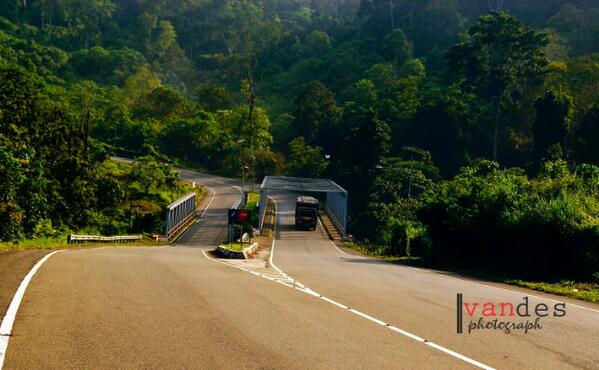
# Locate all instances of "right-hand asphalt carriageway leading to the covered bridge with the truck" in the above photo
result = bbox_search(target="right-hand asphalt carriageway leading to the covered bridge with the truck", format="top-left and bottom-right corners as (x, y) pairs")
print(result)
(274, 194), (599, 369)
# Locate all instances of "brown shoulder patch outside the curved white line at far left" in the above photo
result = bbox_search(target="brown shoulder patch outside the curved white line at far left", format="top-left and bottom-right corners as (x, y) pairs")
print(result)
(0, 250), (52, 318)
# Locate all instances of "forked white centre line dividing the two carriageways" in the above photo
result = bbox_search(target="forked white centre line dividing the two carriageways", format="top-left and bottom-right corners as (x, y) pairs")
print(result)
(203, 198), (494, 370)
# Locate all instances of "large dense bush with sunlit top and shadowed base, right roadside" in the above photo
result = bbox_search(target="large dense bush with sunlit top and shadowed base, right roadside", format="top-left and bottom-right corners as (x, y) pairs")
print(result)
(417, 161), (599, 279)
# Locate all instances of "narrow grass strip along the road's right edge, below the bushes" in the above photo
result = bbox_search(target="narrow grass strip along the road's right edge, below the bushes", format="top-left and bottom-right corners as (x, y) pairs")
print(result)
(344, 243), (599, 303)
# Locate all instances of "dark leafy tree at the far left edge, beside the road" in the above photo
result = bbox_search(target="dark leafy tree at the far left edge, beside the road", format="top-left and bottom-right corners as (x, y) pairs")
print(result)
(0, 67), (93, 239)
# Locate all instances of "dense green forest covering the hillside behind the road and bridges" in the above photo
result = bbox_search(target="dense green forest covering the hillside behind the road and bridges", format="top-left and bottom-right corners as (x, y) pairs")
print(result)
(0, 0), (599, 279)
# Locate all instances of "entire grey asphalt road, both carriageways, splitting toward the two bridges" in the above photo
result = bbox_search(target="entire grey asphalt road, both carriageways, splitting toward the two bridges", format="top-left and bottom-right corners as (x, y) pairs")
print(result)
(5, 172), (599, 369)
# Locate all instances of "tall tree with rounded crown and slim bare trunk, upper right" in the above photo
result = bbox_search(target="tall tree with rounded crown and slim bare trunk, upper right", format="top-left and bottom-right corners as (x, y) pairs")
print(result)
(446, 12), (548, 160)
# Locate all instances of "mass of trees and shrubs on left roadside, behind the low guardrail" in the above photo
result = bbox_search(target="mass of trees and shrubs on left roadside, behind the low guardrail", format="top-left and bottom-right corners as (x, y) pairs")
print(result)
(0, 67), (191, 240)
